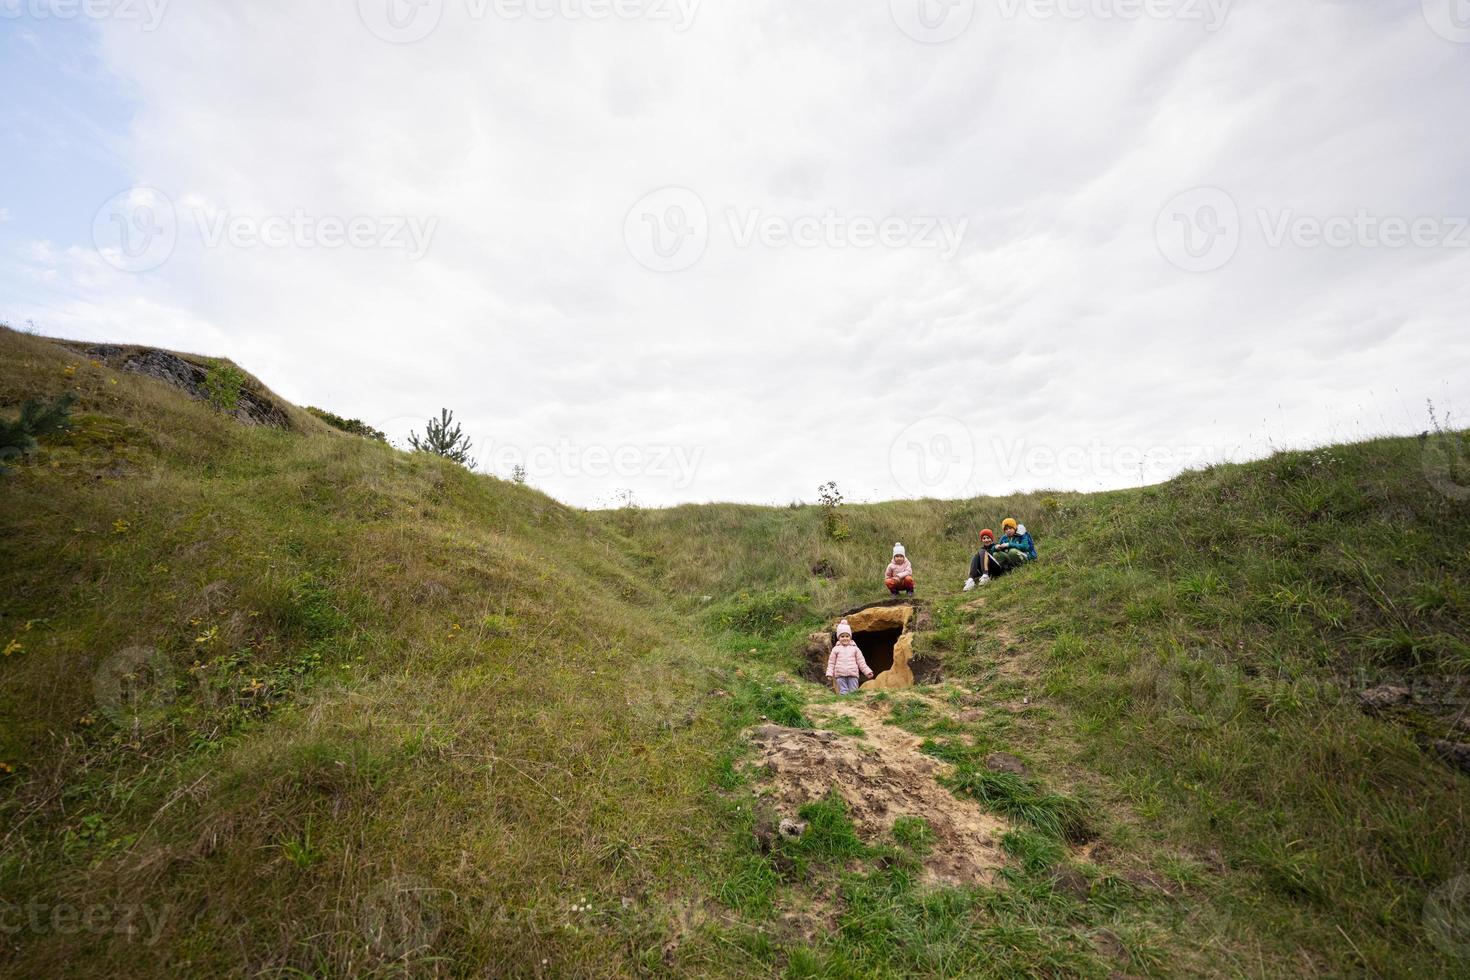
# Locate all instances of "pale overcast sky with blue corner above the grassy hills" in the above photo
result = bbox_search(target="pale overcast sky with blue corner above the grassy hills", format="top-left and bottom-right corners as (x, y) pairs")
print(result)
(0, 0), (1470, 505)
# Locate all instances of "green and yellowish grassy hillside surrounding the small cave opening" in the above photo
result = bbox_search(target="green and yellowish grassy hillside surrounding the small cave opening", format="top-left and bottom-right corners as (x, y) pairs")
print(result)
(0, 331), (1470, 977)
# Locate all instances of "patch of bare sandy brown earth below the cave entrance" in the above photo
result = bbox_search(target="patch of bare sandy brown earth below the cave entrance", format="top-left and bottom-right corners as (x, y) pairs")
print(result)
(750, 698), (1008, 884)
